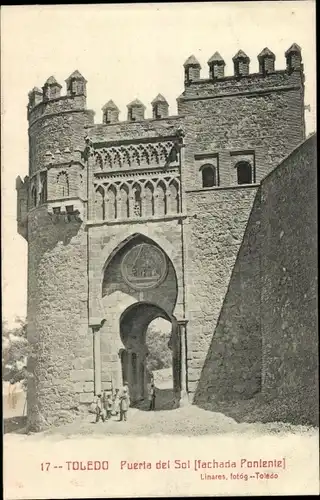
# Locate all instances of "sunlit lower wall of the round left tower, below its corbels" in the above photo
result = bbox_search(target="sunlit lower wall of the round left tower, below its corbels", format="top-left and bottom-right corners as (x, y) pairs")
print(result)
(27, 207), (89, 430)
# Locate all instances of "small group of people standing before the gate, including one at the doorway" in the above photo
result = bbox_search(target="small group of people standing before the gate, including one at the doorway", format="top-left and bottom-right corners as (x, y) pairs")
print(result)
(94, 379), (156, 423)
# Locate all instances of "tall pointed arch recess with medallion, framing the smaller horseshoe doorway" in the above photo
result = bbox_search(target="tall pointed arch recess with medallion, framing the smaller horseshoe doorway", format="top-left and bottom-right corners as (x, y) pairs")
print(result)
(94, 234), (186, 403)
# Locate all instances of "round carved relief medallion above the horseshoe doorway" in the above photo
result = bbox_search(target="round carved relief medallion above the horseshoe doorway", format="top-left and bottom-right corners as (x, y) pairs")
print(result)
(121, 243), (168, 290)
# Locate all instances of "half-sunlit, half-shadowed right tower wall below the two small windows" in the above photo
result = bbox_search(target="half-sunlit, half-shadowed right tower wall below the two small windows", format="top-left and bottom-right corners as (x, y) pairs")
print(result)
(185, 187), (261, 403)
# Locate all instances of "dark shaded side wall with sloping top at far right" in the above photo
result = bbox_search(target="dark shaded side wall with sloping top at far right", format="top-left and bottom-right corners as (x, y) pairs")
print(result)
(261, 135), (318, 414)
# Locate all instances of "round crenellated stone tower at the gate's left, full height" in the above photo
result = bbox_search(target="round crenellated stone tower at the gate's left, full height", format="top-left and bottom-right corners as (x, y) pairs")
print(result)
(21, 71), (94, 430)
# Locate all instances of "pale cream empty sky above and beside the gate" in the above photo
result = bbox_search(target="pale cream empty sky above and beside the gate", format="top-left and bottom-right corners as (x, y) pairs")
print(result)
(1, 1), (316, 325)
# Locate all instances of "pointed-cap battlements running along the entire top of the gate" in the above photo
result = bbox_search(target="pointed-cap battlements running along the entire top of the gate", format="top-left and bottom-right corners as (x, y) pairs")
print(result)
(28, 43), (304, 129)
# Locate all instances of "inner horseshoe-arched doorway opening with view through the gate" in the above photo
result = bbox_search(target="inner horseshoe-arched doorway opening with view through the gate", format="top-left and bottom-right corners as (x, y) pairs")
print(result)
(120, 302), (179, 409)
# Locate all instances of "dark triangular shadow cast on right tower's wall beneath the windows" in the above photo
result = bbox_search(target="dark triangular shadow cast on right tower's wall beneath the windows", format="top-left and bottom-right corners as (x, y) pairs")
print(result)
(194, 189), (262, 407)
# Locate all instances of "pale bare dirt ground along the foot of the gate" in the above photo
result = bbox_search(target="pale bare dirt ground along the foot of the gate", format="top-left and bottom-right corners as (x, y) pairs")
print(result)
(4, 405), (318, 440)
